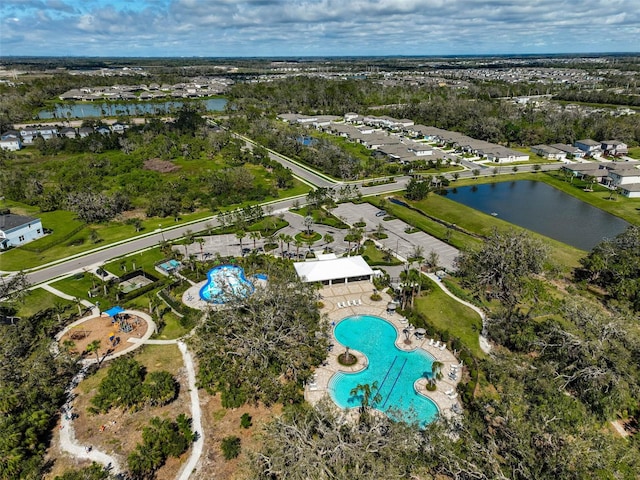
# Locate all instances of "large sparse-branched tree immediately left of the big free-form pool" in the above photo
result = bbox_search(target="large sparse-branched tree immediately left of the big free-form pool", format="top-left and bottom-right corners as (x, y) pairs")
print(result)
(194, 268), (327, 406)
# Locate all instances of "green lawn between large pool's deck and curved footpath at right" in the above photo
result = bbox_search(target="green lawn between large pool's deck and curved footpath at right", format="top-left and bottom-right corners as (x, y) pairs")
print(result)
(414, 280), (484, 358)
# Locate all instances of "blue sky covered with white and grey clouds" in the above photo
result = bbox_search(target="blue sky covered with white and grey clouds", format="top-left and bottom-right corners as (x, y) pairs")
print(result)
(0, 0), (640, 57)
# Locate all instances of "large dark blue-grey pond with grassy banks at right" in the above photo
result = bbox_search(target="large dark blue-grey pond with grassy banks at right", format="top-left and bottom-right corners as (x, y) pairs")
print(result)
(446, 180), (629, 250)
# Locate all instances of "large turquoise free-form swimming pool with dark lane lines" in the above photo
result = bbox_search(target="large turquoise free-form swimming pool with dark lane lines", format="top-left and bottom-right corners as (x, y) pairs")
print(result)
(329, 315), (438, 426)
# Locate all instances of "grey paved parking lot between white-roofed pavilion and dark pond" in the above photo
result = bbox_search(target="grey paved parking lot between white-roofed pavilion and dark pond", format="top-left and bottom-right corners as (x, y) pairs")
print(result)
(332, 203), (460, 270)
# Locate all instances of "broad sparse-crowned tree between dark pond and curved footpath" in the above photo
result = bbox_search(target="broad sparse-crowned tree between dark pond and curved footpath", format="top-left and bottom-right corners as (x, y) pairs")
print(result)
(456, 229), (548, 315)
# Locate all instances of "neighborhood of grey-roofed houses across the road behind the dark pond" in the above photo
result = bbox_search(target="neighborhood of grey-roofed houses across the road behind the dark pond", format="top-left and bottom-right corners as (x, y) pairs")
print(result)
(278, 113), (640, 198)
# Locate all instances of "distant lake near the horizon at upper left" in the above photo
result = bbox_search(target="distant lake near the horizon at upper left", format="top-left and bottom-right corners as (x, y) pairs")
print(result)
(38, 98), (227, 120)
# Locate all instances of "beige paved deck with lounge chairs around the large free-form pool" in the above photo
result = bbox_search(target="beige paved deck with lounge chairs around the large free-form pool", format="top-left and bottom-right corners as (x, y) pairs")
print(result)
(305, 281), (461, 418)
